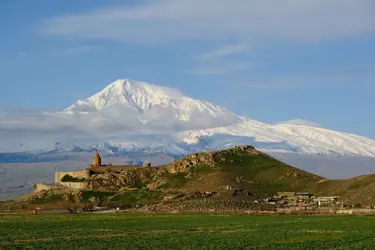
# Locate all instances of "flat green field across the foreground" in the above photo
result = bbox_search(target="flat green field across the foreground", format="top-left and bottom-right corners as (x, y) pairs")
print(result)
(0, 214), (375, 250)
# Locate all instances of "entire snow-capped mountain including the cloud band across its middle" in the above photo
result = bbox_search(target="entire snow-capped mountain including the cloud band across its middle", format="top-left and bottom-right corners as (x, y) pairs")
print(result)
(0, 80), (375, 157)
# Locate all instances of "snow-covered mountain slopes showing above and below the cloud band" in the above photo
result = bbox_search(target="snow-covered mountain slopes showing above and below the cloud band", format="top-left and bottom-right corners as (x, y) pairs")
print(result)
(59, 80), (375, 157)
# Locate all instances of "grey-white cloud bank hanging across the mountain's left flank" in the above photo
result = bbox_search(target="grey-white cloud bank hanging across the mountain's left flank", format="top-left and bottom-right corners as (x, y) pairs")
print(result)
(0, 105), (237, 153)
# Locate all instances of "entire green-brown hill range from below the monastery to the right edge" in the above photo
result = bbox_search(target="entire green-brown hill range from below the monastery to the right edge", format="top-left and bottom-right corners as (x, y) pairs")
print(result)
(10, 146), (375, 208)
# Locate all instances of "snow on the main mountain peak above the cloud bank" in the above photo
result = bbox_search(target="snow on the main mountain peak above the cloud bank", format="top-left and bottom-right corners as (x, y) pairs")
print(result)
(64, 79), (233, 122)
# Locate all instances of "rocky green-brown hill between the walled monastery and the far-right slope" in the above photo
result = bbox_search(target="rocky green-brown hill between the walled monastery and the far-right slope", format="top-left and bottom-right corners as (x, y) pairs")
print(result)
(83, 146), (323, 195)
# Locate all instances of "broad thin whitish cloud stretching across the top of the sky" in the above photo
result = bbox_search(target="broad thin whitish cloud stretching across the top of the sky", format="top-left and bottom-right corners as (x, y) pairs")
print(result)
(39, 0), (375, 43)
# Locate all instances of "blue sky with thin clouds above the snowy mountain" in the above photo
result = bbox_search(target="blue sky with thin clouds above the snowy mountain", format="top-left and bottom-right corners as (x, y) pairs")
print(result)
(0, 0), (375, 138)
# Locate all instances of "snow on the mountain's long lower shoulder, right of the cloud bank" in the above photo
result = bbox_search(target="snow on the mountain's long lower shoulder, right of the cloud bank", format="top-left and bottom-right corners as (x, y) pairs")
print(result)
(183, 119), (375, 157)
